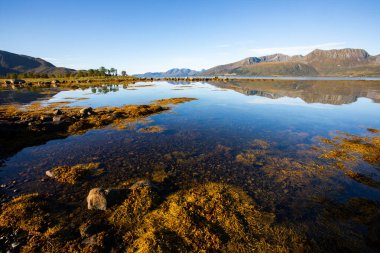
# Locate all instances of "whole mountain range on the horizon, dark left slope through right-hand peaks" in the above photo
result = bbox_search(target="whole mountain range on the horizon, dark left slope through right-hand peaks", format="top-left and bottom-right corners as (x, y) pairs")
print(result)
(0, 48), (380, 78)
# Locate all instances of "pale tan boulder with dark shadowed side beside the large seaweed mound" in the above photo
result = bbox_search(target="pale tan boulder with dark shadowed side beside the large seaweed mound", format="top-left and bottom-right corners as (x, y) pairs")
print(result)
(87, 188), (129, 210)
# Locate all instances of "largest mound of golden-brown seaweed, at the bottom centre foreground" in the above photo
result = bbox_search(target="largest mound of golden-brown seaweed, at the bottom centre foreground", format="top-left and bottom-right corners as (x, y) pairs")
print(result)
(109, 183), (306, 252)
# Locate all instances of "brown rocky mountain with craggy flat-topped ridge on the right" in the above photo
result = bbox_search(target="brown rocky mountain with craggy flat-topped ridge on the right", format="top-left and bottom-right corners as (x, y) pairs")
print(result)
(202, 48), (380, 76)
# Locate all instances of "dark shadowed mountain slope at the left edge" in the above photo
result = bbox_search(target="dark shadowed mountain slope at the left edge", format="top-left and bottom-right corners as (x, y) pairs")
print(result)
(0, 50), (75, 76)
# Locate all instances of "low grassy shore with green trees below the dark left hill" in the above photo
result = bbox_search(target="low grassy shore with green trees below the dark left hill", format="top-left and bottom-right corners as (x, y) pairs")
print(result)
(6, 66), (127, 79)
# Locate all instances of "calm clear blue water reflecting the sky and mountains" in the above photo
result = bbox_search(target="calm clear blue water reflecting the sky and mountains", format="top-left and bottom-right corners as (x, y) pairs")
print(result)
(0, 81), (380, 227)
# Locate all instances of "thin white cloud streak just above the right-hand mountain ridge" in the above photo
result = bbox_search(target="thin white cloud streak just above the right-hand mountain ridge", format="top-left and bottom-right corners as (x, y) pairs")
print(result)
(249, 42), (346, 56)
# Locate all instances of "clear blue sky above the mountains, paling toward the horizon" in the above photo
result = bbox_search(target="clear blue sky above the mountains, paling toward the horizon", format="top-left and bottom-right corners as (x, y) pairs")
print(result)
(0, 0), (380, 74)
